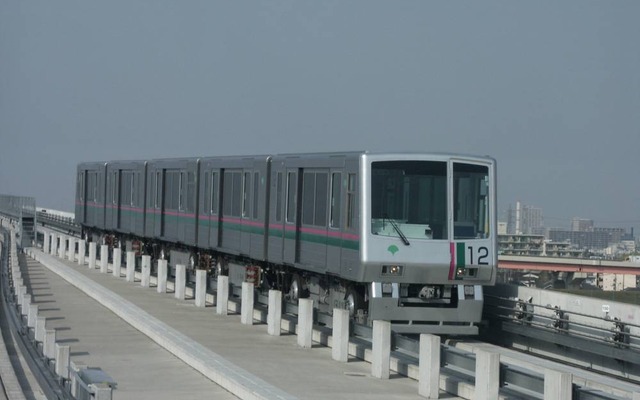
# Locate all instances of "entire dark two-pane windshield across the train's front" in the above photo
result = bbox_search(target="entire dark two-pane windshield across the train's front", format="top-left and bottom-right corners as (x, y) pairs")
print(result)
(371, 161), (490, 244)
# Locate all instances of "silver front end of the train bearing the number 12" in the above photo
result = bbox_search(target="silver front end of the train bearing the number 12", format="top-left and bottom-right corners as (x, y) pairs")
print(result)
(358, 154), (497, 335)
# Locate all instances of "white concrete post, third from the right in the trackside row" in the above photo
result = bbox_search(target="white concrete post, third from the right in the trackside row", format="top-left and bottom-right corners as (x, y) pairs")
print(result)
(418, 333), (440, 399)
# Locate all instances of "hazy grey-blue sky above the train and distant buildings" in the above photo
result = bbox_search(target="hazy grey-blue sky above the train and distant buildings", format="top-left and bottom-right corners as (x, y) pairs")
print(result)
(0, 0), (640, 233)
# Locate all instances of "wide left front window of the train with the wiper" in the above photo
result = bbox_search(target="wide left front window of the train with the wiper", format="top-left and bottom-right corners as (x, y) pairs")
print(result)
(371, 161), (447, 244)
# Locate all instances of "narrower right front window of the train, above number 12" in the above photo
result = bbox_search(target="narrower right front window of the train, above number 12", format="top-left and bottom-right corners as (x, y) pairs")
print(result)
(453, 163), (490, 239)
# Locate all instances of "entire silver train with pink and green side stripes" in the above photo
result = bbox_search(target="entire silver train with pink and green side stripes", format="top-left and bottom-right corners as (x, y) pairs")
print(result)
(75, 151), (498, 335)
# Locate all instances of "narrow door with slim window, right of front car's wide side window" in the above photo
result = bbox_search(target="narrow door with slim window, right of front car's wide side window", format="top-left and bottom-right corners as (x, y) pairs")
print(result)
(327, 169), (346, 275)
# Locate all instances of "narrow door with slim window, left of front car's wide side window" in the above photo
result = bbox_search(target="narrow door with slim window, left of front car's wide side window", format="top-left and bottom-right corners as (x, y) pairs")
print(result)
(283, 168), (302, 264)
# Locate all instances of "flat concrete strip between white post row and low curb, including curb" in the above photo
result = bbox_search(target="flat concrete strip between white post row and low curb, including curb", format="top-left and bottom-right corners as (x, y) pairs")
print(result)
(29, 249), (436, 399)
